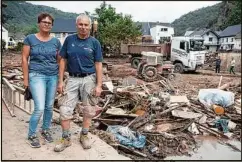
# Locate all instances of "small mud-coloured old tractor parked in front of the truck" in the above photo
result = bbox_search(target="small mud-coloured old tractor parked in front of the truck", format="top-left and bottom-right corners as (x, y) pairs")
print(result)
(137, 52), (175, 82)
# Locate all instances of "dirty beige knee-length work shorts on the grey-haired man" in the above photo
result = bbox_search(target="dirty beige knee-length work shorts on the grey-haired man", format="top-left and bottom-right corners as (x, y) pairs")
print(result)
(59, 74), (97, 120)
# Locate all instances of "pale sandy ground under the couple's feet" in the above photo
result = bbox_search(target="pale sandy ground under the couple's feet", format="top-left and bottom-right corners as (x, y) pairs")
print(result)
(2, 103), (129, 160)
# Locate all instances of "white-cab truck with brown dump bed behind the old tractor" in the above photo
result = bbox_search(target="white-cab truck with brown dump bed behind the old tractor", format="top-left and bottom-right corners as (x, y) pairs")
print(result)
(121, 37), (206, 73)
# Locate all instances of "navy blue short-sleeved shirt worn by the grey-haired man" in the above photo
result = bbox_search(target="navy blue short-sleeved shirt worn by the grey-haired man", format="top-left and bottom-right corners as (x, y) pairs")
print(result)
(60, 34), (103, 74)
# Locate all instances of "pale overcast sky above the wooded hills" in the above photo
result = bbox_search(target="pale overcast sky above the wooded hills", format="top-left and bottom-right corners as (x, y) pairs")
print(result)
(27, 1), (221, 23)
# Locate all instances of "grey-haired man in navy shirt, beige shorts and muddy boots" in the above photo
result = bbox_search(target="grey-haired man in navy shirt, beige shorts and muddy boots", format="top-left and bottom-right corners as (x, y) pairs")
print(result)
(54, 15), (103, 152)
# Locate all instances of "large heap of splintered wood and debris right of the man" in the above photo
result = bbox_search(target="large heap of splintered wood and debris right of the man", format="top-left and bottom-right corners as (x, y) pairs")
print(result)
(69, 80), (241, 160)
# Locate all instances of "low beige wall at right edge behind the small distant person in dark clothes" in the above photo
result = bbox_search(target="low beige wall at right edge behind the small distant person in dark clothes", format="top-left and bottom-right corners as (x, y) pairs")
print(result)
(219, 52), (241, 72)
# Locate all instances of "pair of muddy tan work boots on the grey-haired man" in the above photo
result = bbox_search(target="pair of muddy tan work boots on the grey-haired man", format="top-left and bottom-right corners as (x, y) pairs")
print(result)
(54, 133), (91, 152)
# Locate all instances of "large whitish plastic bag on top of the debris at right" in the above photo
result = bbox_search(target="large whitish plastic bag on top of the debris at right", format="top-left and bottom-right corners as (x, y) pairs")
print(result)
(198, 89), (234, 107)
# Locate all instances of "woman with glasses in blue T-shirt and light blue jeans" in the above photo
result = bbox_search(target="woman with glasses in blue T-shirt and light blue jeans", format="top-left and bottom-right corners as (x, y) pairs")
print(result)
(22, 13), (61, 148)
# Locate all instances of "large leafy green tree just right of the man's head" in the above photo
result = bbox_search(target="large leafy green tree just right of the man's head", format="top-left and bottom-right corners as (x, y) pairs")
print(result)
(95, 2), (141, 53)
